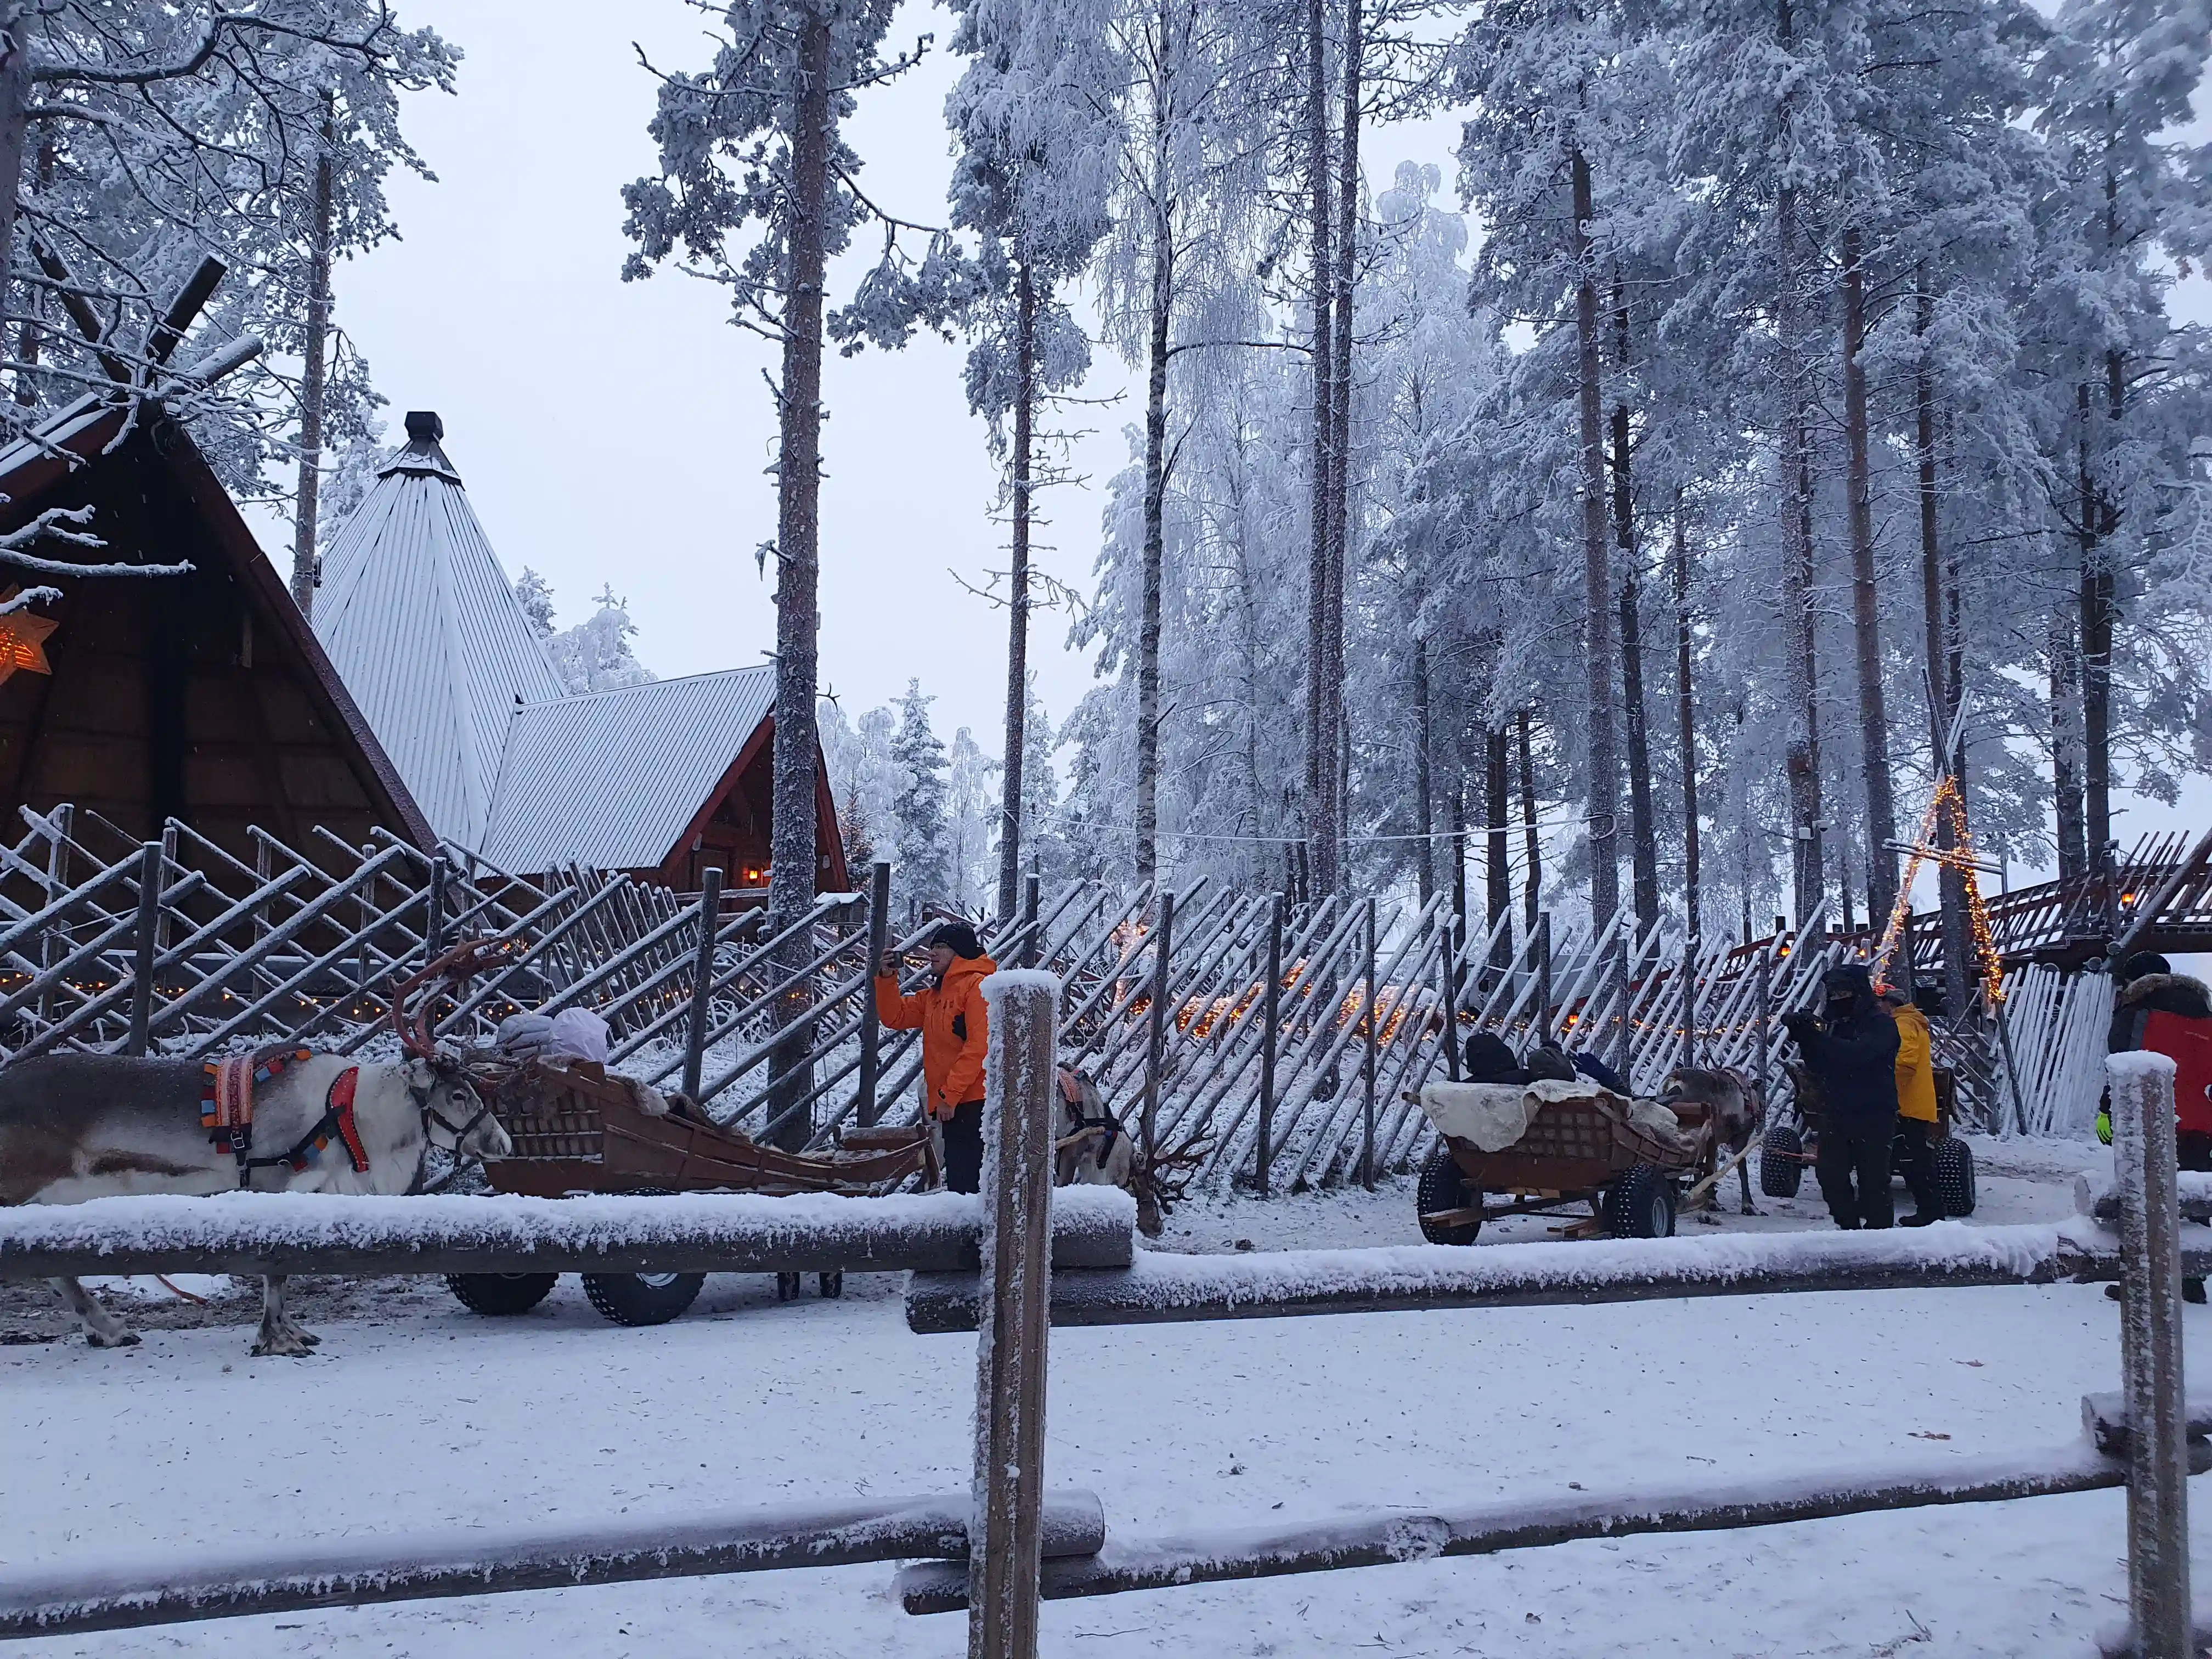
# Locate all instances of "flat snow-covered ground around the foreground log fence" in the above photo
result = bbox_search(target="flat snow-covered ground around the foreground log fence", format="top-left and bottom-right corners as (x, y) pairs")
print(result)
(0, 1144), (2212, 1659)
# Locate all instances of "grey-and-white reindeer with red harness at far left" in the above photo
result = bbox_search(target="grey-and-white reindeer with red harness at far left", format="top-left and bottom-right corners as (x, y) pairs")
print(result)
(0, 947), (511, 1356)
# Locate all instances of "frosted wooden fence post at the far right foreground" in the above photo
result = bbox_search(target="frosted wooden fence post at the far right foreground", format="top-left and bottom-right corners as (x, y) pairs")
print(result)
(2106, 1053), (2194, 1659)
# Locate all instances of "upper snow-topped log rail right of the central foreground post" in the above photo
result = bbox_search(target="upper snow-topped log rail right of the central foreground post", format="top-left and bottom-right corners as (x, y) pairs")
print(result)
(907, 1221), (2212, 1334)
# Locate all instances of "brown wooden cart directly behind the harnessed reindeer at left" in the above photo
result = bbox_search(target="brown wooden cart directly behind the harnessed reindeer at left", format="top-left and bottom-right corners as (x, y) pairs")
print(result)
(447, 1055), (938, 1325)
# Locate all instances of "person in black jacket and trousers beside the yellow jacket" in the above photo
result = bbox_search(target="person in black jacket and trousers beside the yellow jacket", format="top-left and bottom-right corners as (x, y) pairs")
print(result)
(1783, 962), (1898, 1228)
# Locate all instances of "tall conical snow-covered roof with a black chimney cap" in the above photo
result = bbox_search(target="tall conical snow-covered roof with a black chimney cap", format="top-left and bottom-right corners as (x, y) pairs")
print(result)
(314, 411), (571, 847)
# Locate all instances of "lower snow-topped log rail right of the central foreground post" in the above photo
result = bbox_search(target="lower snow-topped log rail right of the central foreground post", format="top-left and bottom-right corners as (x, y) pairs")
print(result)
(898, 1440), (2212, 1612)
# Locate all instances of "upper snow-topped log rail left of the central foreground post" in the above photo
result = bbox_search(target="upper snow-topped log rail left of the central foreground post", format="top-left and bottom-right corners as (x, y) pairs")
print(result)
(0, 1188), (1137, 1278)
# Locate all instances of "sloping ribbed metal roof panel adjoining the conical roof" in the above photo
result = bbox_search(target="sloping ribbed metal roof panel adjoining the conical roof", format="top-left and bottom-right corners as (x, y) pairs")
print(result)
(482, 666), (776, 876)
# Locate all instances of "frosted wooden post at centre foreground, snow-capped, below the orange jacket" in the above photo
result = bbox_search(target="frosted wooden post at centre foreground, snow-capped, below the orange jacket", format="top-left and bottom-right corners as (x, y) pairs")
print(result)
(969, 971), (1059, 1659)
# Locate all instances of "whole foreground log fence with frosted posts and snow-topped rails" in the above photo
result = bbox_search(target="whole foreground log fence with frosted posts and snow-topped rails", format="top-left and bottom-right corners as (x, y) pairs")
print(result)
(0, 1035), (2212, 1659)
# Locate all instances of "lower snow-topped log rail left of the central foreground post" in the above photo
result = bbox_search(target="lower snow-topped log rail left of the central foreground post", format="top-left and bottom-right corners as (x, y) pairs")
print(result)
(0, 1491), (1106, 1639)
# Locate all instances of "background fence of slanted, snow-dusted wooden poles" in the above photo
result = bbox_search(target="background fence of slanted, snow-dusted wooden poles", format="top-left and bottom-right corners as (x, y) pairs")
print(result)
(0, 805), (2108, 1192)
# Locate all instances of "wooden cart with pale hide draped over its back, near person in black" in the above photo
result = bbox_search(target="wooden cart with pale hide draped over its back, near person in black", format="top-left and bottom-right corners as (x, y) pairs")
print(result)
(1418, 1086), (1714, 1245)
